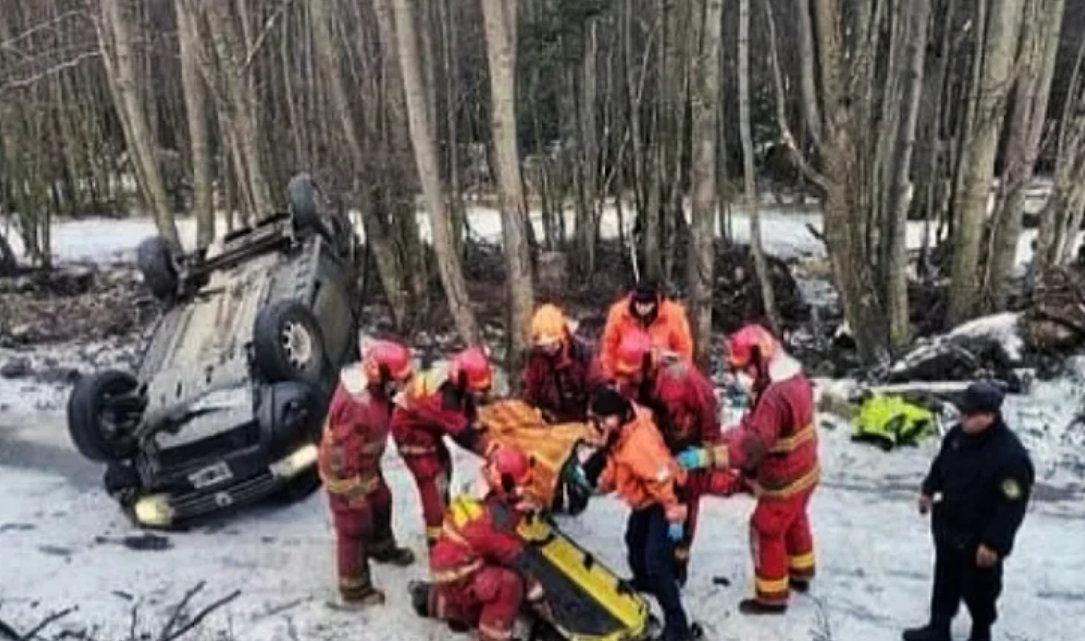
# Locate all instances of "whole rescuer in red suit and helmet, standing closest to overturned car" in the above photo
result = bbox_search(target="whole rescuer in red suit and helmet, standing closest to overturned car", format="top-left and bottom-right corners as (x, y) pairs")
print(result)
(318, 341), (414, 607)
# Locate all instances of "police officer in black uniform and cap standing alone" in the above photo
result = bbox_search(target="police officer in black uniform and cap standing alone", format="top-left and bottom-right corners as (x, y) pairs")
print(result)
(904, 381), (1034, 641)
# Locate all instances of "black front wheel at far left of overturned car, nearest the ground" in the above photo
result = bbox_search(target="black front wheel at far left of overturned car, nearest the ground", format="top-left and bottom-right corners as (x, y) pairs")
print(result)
(67, 370), (143, 463)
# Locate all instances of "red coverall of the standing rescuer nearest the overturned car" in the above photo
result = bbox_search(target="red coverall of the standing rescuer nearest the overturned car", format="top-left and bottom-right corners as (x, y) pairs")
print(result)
(319, 384), (396, 600)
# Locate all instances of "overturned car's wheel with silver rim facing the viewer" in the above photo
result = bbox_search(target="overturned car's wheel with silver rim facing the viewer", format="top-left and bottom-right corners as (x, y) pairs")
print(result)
(253, 300), (328, 384)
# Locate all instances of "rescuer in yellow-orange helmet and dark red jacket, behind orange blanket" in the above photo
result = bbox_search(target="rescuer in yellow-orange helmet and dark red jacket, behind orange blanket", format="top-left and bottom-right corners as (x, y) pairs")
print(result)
(522, 305), (602, 423)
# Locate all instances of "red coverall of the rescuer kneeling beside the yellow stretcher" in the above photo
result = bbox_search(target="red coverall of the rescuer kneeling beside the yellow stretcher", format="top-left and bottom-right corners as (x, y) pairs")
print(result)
(430, 495), (543, 641)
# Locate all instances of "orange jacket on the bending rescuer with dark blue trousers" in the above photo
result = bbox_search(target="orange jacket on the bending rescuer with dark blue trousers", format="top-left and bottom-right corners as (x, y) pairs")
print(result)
(599, 407), (686, 521)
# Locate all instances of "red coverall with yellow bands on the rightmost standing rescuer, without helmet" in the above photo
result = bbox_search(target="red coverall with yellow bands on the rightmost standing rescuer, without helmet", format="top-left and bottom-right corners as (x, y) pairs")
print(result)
(713, 357), (820, 605)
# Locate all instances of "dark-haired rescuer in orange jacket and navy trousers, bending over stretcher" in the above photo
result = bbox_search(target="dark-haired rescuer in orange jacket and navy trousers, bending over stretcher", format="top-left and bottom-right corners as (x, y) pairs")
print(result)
(583, 388), (701, 641)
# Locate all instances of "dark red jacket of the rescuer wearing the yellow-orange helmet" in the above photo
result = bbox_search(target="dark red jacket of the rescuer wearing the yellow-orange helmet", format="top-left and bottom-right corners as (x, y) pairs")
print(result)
(523, 332), (603, 423)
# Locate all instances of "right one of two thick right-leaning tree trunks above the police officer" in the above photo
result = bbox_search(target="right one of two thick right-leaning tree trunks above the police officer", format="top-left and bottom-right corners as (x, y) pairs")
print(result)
(981, 0), (1065, 311)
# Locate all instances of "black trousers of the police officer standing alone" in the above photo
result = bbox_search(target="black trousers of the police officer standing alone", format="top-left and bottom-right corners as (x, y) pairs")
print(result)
(931, 542), (1003, 631)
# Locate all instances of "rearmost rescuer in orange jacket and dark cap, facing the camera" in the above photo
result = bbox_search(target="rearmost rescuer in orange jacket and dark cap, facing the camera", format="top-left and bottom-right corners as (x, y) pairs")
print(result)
(599, 282), (693, 377)
